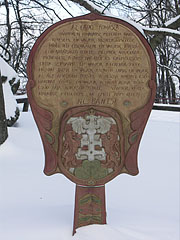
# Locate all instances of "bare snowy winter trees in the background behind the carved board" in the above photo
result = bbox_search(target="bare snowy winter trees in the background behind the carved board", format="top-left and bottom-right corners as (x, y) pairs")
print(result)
(0, 0), (180, 104)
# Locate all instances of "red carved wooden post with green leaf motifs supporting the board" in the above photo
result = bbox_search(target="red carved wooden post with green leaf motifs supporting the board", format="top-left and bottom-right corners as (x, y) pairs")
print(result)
(73, 185), (106, 235)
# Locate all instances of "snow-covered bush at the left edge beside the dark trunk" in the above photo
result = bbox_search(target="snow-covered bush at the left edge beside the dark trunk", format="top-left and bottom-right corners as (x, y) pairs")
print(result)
(0, 57), (20, 127)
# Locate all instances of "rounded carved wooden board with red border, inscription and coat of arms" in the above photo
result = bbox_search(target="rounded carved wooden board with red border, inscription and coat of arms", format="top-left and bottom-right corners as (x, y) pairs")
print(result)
(27, 14), (156, 186)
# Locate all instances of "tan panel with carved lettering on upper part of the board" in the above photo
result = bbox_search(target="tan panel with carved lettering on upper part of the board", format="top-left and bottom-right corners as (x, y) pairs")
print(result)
(33, 20), (151, 117)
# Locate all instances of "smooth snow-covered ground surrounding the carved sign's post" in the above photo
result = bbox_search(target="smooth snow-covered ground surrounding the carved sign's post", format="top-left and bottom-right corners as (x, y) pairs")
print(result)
(0, 110), (180, 240)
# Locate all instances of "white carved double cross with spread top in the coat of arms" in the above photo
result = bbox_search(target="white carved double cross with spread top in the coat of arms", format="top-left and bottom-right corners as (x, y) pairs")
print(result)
(67, 114), (116, 161)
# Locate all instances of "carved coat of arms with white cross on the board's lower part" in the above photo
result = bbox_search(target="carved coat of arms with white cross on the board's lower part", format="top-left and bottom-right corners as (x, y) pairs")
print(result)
(59, 107), (123, 185)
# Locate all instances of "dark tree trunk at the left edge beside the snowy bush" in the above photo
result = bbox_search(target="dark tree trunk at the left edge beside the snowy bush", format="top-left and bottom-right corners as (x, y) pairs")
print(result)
(0, 75), (8, 144)
